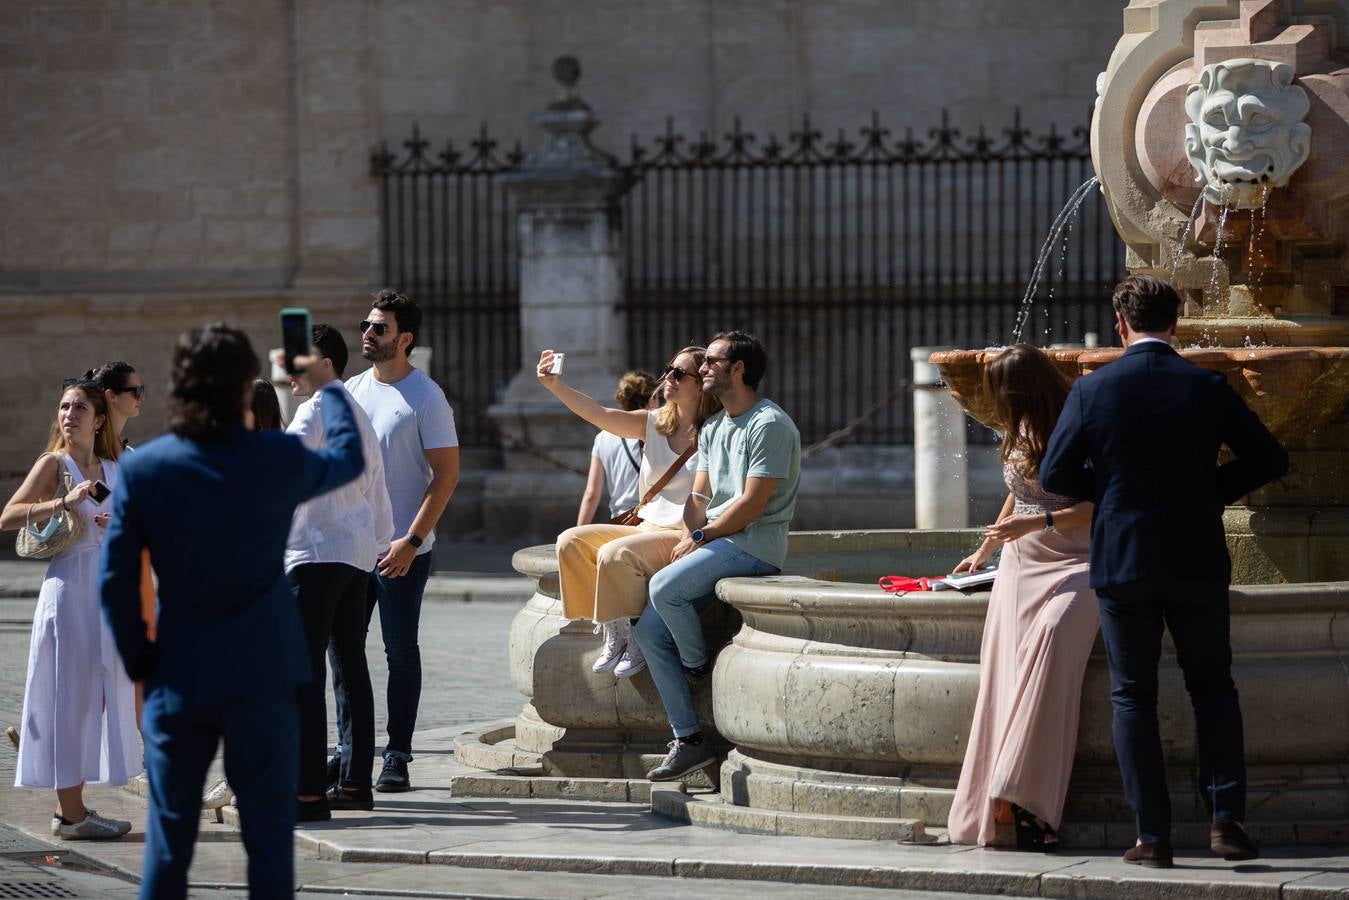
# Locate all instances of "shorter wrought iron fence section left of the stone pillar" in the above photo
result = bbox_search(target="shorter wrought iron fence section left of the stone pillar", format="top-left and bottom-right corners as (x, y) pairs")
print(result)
(371, 127), (525, 447)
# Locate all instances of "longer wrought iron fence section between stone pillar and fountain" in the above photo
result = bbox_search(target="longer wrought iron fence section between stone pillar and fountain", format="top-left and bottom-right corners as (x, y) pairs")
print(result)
(623, 115), (1122, 443)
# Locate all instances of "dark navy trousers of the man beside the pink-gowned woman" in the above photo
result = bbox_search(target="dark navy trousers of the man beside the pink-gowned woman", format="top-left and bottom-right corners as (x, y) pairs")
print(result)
(1097, 579), (1246, 843)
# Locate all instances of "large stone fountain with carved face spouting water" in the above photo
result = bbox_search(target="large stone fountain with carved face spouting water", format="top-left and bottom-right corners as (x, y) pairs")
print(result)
(455, 0), (1349, 847)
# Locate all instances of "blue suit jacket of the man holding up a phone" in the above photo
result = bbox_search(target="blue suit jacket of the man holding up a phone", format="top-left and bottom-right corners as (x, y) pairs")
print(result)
(103, 389), (364, 704)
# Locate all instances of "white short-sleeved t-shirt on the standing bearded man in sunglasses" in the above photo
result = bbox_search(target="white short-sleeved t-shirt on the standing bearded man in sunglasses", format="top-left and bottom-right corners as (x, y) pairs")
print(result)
(347, 368), (459, 556)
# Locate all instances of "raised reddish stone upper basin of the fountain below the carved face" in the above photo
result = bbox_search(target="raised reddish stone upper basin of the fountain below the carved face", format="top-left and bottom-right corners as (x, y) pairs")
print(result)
(929, 347), (1349, 441)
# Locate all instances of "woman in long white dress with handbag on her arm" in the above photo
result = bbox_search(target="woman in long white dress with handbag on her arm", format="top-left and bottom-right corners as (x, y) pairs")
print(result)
(0, 382), (142, 839)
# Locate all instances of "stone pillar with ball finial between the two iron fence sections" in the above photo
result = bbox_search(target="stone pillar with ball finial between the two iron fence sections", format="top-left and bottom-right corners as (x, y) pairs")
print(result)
(484, 57), (626, 537)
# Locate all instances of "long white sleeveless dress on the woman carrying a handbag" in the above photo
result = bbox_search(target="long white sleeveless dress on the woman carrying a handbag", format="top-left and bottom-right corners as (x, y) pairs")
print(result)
(15, 456), (142, 788)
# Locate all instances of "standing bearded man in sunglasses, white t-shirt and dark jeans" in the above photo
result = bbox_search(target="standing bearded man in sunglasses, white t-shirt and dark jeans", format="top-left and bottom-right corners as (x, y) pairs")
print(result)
(329, 287), (459, 793)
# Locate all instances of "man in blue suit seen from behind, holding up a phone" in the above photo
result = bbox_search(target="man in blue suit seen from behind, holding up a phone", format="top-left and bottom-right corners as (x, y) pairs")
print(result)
(103, 324), (364, 899)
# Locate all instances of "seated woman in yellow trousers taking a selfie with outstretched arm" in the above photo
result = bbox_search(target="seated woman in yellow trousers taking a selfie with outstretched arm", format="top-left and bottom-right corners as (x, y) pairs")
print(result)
(538, 347), (720, 677)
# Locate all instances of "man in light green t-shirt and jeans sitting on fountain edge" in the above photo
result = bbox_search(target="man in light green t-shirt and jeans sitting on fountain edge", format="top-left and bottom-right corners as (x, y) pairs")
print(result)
(635, 332), (801, 781)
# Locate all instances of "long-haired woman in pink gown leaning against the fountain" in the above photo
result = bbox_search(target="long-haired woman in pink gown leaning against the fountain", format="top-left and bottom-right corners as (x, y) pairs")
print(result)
(948, 344), (1098, 850)
